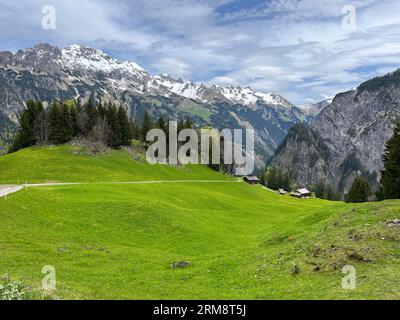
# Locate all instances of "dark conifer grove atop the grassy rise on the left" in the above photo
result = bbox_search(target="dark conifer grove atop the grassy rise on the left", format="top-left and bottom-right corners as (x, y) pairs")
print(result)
(9, 98), (200, 152)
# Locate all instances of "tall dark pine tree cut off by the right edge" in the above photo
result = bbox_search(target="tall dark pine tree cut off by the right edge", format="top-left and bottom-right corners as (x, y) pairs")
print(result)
(378, 123), (400, 200)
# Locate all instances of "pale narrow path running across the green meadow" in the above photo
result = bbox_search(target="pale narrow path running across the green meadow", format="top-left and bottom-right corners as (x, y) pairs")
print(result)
(0, 180), (241, 198)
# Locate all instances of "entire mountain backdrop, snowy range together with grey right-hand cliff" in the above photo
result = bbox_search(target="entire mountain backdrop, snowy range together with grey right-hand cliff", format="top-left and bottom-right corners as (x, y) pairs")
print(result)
(6, 44), (400, 191)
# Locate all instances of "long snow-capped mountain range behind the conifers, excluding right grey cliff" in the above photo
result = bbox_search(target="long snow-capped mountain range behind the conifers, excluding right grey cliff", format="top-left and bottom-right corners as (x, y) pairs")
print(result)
(0, 44), (319, 168)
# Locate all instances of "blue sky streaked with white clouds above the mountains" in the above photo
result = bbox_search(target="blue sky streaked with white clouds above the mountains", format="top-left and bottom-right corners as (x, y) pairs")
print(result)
(0, 0), (400, 104)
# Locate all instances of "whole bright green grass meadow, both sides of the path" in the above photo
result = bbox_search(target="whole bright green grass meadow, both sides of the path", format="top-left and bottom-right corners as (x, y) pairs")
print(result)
(0, 146), (400, 299)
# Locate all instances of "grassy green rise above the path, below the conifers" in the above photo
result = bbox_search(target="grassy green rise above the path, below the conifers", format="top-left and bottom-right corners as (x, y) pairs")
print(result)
(0, 145), (229, 184)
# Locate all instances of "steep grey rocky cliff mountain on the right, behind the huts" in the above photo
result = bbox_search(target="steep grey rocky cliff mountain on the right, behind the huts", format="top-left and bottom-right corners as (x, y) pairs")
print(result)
(270, 70), (400, 192)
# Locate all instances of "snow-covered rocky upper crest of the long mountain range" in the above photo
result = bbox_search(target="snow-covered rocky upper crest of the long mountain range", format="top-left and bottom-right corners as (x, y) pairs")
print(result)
(8, 44), (295, 110)
